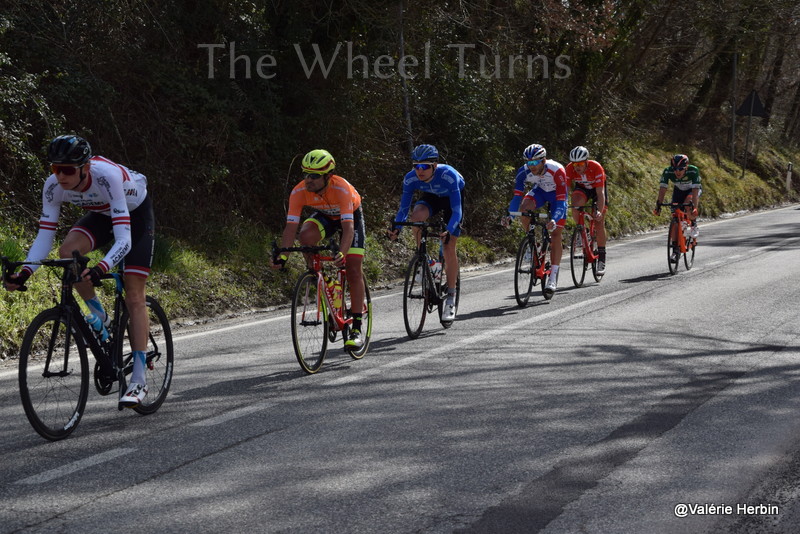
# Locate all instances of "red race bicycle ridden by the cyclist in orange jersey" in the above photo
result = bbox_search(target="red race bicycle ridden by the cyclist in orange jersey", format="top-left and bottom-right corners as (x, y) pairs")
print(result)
(272, 241), (372, 374)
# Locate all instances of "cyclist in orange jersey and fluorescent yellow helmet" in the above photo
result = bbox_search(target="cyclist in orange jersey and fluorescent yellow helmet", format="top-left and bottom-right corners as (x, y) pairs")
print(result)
(272, 150), (366, 349)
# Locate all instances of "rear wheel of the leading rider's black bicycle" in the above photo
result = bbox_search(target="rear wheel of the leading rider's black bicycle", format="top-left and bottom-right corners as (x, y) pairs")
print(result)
(116, 296), (175, 415)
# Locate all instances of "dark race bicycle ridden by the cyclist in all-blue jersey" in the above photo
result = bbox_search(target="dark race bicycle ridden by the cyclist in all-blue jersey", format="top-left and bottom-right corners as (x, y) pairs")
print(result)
(392, 222), (461, 339)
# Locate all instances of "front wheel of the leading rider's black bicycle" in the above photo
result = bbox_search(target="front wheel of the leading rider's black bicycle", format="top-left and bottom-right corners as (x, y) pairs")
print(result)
(19, 308), (89, 441)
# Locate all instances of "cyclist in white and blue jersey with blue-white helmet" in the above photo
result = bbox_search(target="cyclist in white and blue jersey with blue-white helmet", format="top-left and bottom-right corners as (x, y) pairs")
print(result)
(502, 144), (568, 298)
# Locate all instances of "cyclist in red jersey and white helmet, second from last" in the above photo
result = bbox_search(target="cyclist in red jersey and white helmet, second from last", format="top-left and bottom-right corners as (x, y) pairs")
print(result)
(566, 146), (608, 274)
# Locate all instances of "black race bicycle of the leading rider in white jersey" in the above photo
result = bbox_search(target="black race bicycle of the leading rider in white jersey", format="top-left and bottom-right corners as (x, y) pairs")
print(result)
(2, 251), (174, 441)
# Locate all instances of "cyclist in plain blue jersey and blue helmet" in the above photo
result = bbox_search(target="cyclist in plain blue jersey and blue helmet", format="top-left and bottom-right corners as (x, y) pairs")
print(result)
(389, 145), (464, 321)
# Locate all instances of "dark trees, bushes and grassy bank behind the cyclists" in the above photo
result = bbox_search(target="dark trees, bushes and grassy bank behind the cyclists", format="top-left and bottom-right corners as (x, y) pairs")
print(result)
(0, 0), (800, 356)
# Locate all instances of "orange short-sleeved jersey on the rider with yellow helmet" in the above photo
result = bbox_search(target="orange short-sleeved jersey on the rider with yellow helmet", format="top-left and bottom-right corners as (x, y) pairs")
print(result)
(286, 175), (361, 223)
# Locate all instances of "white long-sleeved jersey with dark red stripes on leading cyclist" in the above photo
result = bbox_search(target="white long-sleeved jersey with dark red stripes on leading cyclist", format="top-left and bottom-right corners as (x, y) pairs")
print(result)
(25, 156), (147, 272)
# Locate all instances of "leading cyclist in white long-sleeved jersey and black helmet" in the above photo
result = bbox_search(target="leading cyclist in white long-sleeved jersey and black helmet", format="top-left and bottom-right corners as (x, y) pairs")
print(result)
(4, 135), (155, 407)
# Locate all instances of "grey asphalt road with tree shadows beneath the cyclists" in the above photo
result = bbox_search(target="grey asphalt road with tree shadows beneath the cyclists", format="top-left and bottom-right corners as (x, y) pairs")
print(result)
(0, 206), (800, 533)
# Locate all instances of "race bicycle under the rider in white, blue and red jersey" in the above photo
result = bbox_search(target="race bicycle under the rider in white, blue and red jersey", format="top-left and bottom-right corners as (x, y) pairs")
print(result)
(509, 209), (553, 307)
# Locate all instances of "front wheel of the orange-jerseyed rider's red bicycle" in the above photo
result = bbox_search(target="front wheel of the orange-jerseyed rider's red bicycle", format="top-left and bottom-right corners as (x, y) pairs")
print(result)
(292, 271), (329, 374)
